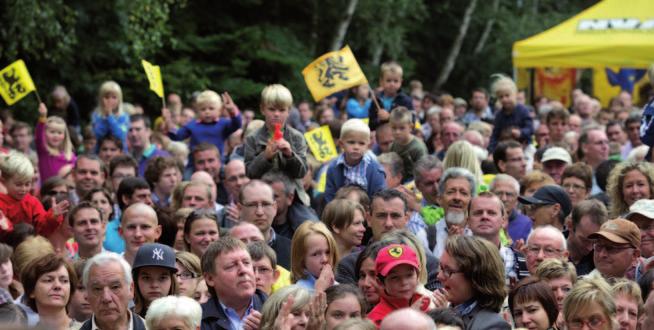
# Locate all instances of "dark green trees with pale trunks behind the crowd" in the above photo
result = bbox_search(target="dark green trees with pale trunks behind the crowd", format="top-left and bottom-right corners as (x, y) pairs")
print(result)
(0, 0), (597, 119)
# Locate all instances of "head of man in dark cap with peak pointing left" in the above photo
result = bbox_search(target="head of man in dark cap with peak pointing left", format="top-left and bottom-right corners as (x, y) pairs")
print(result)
(518, 185), (572, 230)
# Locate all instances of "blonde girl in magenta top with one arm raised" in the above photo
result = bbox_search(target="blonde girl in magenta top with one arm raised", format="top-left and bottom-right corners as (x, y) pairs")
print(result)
(34, 103), (77, 182)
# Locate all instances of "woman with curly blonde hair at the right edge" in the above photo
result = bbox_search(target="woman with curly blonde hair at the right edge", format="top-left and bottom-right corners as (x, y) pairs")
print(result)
(606, 162), (654, 218)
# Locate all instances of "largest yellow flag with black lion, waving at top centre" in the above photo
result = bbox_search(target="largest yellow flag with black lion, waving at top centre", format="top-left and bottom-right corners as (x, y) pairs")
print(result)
(302, 46), (368, 102)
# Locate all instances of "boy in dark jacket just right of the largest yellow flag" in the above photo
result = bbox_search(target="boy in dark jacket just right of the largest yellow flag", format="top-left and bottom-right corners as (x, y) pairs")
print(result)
(368, 61), (413, 130)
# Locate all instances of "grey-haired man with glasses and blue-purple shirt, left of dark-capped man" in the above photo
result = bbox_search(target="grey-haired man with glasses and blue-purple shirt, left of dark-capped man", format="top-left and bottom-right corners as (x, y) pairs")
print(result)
(490, 174), (532, 242)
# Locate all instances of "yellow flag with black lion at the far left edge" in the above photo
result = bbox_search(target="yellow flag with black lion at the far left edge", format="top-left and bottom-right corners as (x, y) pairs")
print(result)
(0, 60), (36, 105)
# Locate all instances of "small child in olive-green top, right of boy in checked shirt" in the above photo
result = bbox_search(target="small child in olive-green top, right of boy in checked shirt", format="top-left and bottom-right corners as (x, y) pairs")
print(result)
(390, 107), (427, 182)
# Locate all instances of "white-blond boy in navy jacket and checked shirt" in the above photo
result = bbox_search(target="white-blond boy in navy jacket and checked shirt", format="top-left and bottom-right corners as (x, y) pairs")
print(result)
(325, 119), (386, 203)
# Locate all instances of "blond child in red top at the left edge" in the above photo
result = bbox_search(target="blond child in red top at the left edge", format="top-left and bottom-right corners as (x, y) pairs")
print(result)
(0, 151), (69, 237)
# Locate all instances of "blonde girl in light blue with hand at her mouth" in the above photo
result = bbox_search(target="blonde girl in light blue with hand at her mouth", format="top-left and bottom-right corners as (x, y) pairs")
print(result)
(291, 221), (338, 291)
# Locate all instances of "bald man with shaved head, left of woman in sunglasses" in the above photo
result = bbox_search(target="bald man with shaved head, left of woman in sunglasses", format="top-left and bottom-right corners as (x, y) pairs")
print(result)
(118, 203), (161, 265)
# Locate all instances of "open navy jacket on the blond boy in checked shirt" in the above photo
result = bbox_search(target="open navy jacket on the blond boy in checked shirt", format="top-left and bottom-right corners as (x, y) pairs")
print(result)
(324, 158), (386, 204)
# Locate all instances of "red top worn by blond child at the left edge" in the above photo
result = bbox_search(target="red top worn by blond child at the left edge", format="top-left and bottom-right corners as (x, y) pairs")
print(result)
(0, 194), (64, 237)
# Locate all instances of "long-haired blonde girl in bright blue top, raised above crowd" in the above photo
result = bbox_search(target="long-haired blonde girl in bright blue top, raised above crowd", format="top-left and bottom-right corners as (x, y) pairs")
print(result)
(91, 81), (129, 152)
